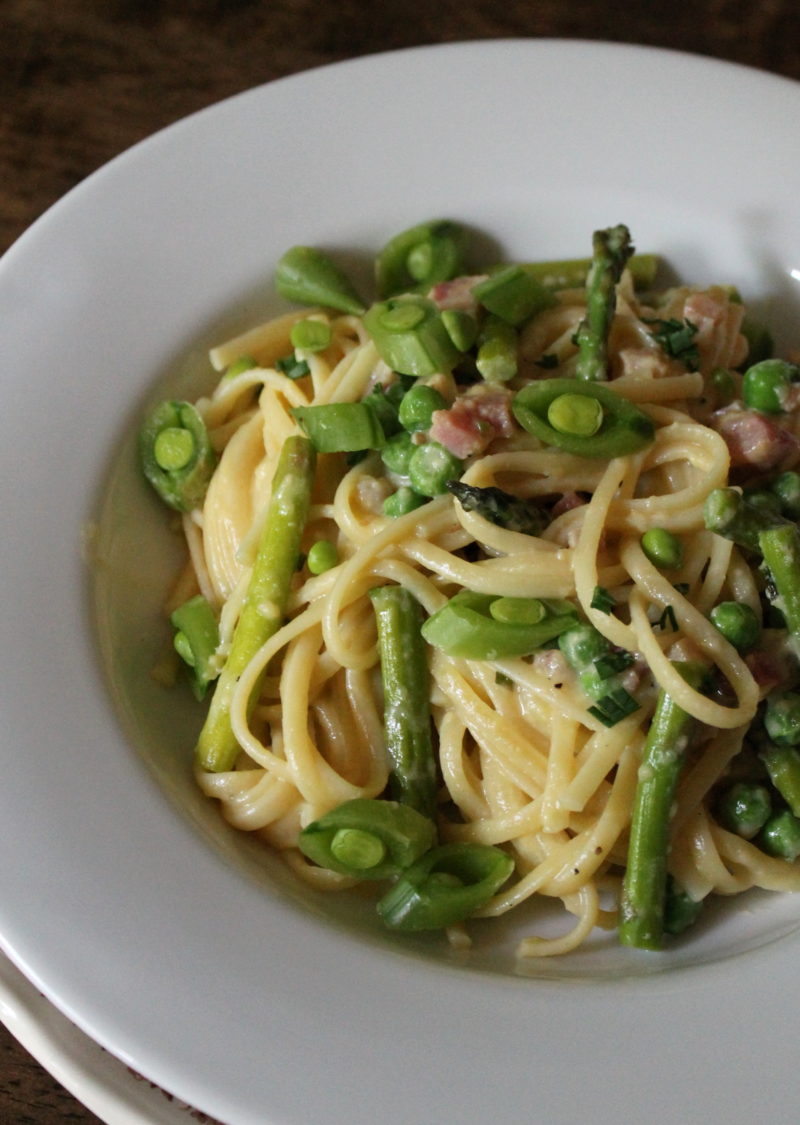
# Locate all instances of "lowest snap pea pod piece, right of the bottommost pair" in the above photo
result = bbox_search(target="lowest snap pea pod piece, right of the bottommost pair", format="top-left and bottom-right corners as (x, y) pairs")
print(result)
(378, 844), (514, 933)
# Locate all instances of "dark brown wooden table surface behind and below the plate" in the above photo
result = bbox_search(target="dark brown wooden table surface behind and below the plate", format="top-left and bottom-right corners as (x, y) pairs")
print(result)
(0, 0), (800, 1125)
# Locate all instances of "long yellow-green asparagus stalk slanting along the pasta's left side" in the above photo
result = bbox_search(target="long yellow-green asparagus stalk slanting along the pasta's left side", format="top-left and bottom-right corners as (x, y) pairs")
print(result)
(195, 434), (315, 772)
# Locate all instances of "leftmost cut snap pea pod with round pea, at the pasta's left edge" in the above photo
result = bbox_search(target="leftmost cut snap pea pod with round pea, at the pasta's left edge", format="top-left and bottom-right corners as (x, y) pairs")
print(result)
(138, 402), (217, 512)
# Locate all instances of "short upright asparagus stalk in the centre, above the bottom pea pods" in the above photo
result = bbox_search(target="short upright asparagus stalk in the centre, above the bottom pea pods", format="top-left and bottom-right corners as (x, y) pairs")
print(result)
(369, 586), (437, 817)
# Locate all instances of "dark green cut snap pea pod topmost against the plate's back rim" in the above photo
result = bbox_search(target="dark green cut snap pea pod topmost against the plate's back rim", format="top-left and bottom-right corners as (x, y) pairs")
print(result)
(375, 219), (467, 299)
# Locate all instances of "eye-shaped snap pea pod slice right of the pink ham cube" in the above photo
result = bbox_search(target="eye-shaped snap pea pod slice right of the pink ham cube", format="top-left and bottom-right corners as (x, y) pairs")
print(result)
(512, 379), (655, 459)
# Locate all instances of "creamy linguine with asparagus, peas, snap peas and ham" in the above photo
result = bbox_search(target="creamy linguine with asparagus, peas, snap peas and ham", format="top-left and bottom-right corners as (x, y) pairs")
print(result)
(140, 221), (800, 957)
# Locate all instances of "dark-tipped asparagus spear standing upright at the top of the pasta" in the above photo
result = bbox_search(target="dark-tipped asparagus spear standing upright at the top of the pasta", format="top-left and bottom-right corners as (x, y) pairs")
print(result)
(575, 224), (633, 381)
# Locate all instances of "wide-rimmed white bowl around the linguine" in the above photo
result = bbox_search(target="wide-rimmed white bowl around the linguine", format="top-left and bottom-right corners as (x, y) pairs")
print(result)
(0, 41), (800, 1125)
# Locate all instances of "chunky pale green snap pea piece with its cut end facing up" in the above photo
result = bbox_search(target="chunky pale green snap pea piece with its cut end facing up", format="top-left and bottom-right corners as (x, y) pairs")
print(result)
(363, 296), (460, 378)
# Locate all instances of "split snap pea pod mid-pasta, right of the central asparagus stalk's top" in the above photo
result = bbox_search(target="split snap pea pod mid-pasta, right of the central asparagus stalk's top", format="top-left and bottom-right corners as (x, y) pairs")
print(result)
(422, 591), (577, 660)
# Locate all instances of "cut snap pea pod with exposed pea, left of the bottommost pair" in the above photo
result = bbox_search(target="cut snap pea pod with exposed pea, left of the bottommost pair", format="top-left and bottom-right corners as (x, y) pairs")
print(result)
(298, 798), (437, 879)
